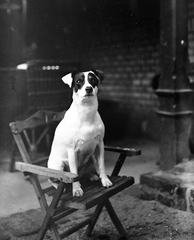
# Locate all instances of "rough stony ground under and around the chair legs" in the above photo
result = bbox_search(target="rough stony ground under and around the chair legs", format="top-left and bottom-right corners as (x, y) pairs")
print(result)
(0, 185), (194, 240)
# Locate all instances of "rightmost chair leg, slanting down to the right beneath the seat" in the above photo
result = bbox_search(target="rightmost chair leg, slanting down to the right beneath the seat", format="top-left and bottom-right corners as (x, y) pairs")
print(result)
(104, 199), (129, 239)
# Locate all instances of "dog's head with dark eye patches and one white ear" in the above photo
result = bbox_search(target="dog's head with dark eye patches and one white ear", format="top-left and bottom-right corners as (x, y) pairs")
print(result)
(62, 69), (104, 99)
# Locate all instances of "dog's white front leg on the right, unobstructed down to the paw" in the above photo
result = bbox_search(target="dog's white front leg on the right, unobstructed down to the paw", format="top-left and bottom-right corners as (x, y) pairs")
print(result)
(97, 140), (112, 187)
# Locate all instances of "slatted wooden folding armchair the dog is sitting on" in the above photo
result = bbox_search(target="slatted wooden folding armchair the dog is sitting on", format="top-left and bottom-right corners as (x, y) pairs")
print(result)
(10, 110), (141, 240)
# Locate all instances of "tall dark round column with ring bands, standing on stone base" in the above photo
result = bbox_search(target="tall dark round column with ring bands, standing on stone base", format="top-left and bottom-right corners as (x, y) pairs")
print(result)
(156, 0), (193, 170)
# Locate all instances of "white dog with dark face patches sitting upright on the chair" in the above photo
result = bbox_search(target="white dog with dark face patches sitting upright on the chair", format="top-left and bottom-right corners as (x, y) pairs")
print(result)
(48, 70), (112, 197)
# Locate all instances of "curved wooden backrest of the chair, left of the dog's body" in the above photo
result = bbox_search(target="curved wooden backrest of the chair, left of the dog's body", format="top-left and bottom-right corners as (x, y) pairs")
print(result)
(9, 110), (66, 166)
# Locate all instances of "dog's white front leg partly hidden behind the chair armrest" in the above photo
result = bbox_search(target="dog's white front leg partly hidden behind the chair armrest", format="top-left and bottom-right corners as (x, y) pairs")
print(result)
(68, 148), (83, 197)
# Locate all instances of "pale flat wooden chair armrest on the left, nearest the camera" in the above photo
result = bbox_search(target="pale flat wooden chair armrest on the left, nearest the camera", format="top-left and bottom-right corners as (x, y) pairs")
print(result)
(15, 162), (78, 183)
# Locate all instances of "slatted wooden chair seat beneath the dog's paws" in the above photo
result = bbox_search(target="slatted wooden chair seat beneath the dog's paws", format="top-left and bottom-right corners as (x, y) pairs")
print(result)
(44, 176), (134, 210)
